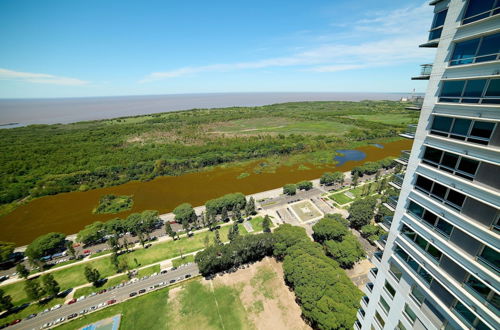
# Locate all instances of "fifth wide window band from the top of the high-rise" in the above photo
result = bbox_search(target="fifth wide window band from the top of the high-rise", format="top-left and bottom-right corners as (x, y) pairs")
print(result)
(422, 147), (479, 181)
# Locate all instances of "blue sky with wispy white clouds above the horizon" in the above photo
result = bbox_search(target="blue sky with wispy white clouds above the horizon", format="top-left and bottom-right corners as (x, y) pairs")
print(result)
(0, 0), (434, 98)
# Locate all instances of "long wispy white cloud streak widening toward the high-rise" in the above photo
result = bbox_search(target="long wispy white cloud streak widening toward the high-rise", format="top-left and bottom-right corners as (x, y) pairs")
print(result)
(140, 1), (432, 83)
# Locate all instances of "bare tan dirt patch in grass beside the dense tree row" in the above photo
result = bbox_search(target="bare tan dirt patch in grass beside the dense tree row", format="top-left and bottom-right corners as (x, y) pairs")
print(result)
(203, 258), (310, 330)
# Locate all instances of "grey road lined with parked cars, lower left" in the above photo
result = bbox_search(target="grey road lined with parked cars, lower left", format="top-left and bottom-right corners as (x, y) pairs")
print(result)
(8, 264), (199, 329)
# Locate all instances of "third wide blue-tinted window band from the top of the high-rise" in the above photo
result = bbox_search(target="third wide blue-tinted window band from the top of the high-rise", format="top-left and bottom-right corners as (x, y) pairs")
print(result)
(439, 78), (500, 104)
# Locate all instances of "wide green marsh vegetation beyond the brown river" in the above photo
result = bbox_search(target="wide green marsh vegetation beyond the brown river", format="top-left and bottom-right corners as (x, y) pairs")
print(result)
(0, 101), (418, 214)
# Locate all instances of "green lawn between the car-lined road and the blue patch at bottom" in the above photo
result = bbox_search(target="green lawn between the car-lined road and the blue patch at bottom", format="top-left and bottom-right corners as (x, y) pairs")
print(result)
(57, 288), (172, 330)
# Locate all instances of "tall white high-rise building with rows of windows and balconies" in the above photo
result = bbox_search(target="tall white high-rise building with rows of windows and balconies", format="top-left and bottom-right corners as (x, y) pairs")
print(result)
(354, 0), (500, 330)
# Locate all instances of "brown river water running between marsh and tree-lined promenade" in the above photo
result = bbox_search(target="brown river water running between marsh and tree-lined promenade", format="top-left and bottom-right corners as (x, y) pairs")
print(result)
(0, 139), (412, 246)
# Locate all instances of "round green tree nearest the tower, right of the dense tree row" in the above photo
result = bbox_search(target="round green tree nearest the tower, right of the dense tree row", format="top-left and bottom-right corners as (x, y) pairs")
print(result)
(325, 234), (365, 269)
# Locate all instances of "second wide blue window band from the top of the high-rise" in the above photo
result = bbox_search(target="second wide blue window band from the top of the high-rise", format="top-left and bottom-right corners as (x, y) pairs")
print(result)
(450, 33), (500, 66)
